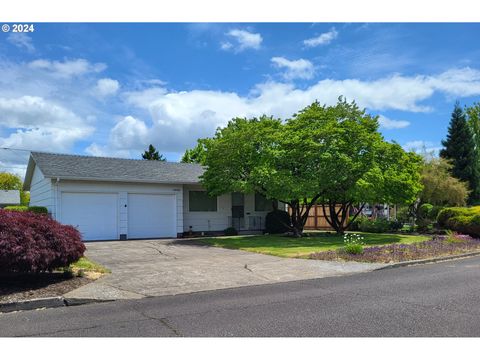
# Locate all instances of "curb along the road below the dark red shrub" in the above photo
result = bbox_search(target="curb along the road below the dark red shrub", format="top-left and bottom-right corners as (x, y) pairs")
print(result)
(0, 296), (115, 314)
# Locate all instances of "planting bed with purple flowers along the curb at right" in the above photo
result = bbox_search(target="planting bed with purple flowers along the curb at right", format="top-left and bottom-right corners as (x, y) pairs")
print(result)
(310, 234), (480, 263)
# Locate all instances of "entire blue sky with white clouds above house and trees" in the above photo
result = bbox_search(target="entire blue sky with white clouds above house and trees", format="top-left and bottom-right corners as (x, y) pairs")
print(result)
(0, 23), (480, 173)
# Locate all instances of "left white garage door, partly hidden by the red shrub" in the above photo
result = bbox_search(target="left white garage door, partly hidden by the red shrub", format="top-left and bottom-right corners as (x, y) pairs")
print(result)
(61, 192), (118, 240)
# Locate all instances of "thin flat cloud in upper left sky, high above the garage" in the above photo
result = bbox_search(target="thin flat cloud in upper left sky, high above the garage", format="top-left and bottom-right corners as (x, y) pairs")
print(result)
(28, 59), (107, 78)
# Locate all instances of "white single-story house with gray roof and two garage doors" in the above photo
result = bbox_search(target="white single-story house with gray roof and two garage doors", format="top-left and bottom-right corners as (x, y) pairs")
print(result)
(24, 152), (278, 240)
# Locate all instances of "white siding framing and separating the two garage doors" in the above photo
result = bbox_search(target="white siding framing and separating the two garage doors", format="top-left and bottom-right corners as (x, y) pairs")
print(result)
(56, 180), (183, 234)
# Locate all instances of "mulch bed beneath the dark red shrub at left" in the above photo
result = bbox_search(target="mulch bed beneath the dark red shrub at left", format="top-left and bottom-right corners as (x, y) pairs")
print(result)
(0, 272), (93, 303)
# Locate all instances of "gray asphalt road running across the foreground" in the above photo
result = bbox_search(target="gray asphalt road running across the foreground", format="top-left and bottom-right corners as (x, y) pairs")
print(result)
(0, 257), (480, 337)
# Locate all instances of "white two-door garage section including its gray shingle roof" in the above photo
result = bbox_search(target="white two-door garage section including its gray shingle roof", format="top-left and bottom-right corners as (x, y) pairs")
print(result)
(24, 152), (204, 241)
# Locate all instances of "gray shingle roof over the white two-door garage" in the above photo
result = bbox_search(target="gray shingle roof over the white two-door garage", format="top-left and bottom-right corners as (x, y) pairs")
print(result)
(27, 152), (203, 184)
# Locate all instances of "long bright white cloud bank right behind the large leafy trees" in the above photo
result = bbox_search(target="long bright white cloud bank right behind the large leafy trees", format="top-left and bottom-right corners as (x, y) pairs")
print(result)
(105, 68), (480, 158)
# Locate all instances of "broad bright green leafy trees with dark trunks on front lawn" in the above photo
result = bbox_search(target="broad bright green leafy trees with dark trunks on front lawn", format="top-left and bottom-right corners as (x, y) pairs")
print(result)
(202, 98), (421, 235)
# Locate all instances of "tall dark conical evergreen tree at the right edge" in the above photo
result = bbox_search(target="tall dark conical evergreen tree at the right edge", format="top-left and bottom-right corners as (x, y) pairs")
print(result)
(440, 102), (479, 204)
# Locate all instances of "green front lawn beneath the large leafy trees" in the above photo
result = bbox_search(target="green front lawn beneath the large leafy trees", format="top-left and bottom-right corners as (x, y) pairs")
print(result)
(201, 232), (430, 257)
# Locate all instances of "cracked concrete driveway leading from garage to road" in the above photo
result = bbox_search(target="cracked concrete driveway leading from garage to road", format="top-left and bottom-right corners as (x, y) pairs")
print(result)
(65, 240), (380, 300)
